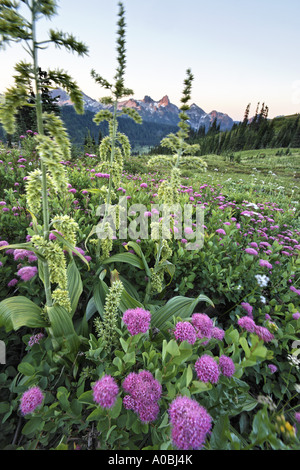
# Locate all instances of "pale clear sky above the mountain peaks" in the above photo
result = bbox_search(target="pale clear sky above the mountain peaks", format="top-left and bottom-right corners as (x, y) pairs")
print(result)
(0, 0), (300, 121)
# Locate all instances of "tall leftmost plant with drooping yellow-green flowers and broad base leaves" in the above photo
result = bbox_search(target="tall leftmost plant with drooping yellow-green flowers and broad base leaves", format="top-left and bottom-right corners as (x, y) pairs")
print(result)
(0, 0), (88, 360)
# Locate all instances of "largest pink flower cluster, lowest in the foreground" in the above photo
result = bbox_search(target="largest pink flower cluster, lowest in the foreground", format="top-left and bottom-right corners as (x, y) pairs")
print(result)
(169, 396), (212, 450)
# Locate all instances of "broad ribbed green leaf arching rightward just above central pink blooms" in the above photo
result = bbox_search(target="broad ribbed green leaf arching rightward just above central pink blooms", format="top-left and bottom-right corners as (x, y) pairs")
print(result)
(151, 294), (214, 329)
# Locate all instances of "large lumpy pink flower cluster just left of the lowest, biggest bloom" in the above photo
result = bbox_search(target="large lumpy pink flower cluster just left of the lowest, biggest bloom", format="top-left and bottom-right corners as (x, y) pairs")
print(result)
(123, 370), (162, 422)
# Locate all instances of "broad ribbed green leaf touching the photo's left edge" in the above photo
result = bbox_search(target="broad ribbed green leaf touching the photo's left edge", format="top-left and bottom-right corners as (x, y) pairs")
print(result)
(0, 296), (47, 332)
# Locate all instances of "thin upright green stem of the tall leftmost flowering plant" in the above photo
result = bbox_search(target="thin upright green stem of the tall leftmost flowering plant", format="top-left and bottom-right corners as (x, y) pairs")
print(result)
(31, 0), (52, 307)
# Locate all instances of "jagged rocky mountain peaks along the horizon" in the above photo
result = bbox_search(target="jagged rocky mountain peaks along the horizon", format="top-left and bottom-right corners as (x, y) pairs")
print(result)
(51, 88), (234, 132)
